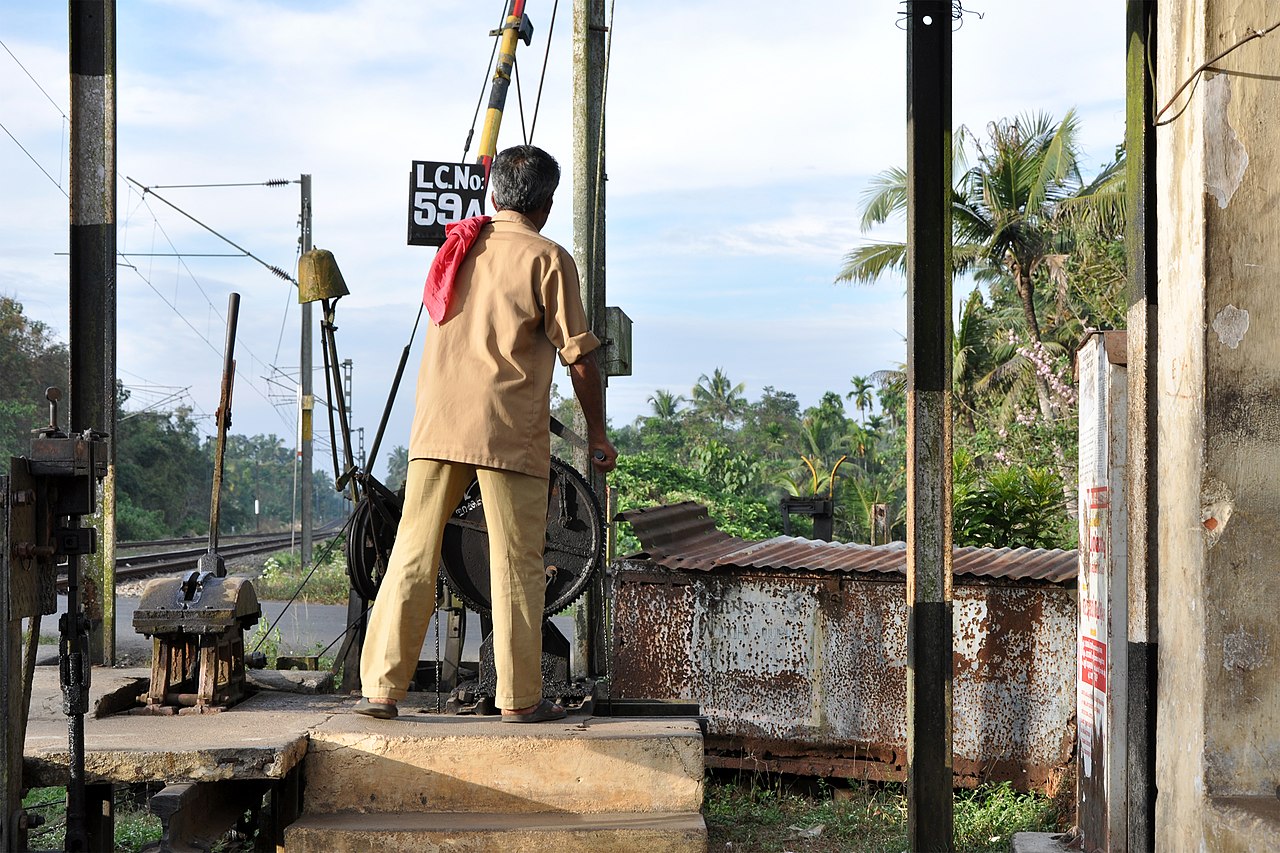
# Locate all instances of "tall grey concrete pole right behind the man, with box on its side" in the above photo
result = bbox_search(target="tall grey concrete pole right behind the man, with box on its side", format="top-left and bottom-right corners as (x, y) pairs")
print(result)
(573, 0), (608, 678)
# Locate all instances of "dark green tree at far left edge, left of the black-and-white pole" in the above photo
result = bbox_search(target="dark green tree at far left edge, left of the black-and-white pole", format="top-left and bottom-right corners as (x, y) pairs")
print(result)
(0, 296), (69, 459)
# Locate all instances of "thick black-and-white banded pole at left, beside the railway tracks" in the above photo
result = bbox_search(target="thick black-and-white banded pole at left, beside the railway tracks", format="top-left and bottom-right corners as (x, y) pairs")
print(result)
(68, 0), (115, 663)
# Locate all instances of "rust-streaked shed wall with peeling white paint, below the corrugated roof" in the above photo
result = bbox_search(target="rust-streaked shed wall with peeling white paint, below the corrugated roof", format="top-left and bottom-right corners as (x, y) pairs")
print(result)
(612, 561), (1076, 788)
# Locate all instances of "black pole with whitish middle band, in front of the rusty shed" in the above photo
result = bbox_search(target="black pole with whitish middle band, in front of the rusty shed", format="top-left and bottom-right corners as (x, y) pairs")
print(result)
(906, 0), (955, 852)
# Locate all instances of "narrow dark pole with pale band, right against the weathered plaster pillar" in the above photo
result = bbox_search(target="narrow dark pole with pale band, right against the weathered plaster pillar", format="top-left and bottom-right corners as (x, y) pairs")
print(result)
(1124, 0), (1160, 853)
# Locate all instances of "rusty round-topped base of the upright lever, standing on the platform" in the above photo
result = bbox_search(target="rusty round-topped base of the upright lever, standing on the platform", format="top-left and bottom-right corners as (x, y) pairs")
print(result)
(133, 571), (261, 715)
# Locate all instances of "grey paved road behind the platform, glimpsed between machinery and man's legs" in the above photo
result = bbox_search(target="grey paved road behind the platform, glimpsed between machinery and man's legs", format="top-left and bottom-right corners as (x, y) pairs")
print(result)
(47, 596), (573, 661)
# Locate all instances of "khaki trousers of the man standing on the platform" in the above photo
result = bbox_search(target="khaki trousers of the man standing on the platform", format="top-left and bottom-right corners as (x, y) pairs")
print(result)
(360, 459), (547, 708)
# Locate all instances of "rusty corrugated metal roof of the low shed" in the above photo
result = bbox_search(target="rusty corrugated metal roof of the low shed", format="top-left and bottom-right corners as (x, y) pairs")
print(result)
(618, 501), (1079, 583)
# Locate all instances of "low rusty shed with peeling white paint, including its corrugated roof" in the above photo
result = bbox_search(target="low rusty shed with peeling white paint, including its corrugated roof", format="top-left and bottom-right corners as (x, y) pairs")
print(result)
(612, 502), (1078, 793)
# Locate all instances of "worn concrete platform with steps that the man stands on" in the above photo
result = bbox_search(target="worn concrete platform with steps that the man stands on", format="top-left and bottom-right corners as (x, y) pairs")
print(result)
(24, 667), (707, 853)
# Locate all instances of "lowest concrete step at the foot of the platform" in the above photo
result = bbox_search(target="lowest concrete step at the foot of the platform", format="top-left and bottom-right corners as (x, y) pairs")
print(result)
(284, 812), (707, 853)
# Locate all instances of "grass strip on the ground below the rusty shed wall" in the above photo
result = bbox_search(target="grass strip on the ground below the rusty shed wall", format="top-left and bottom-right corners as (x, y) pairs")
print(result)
(703, 774), (1057, 853)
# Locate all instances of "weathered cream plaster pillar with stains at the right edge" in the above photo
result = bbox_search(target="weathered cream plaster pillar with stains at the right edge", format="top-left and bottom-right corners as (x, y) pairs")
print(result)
(1155, 0), (1280, 850)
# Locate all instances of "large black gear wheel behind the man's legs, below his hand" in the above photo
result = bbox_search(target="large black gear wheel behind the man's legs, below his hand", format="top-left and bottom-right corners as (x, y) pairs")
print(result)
(442, 456), (604, 617)
